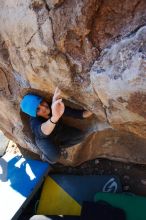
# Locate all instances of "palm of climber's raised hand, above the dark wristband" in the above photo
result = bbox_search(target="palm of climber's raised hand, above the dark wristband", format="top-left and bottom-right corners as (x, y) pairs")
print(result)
(51, 99), (65, 122)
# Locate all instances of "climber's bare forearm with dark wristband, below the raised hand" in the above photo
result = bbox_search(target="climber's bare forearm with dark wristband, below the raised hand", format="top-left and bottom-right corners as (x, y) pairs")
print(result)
(41, 116), (57, 135)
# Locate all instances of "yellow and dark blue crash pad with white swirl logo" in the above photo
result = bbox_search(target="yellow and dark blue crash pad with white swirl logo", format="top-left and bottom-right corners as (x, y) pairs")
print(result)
(37, 175), (121, 216)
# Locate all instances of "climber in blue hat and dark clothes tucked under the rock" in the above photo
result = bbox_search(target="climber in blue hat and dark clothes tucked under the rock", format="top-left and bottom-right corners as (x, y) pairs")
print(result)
(20, 88), (92, 164)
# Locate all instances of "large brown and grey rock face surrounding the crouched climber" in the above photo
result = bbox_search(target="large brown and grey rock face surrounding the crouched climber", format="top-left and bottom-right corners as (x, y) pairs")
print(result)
(0, 0), (146, 166)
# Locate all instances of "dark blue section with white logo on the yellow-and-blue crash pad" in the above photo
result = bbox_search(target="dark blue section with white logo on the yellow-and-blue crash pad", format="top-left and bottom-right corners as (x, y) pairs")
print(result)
(50, 174), (122, 204)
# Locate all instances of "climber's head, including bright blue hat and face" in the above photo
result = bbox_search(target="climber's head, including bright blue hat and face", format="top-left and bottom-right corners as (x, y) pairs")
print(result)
(20, 94), (51, 119)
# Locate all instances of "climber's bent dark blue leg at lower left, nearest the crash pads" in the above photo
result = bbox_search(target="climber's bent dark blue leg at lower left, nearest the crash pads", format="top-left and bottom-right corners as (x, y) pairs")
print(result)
(35, 138), (60, 164)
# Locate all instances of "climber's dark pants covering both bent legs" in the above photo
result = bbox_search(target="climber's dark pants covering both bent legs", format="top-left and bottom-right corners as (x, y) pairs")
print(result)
(35, 124), (86, 164)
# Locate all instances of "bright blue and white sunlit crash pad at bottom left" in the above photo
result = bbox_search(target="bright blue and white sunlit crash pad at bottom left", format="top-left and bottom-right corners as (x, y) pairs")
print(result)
(0, 154), (49, 220)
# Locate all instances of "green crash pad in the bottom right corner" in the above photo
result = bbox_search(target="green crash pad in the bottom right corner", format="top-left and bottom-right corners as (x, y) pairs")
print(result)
(95, 193), (146, 220)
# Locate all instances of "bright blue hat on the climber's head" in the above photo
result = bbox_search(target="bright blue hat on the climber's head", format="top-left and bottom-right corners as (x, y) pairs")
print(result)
(20, 94), (43, 117)
